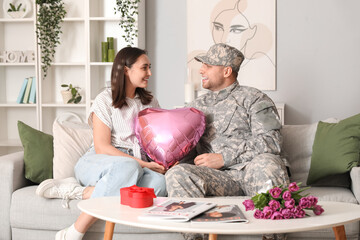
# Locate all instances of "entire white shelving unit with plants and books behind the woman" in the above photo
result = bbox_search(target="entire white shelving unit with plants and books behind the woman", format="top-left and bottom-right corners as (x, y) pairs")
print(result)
(0, 0), (145, 155)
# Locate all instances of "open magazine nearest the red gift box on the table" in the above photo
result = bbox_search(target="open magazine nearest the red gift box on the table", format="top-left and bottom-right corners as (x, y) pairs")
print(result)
(139, 199), (216, 222)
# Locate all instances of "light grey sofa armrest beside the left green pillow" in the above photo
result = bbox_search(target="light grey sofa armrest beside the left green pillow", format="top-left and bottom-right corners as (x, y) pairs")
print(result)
(0, 152), (30, 239)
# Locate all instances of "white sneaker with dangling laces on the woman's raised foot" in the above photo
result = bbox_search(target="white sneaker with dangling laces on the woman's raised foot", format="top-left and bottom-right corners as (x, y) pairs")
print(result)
(36, 177), (85, 208)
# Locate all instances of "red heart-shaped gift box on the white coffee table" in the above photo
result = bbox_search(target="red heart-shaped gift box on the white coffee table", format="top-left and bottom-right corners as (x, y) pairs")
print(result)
(120, 185), (156, 208)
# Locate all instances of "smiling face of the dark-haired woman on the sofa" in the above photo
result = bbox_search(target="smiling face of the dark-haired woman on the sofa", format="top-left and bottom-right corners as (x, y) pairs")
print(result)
(125, 54), (151, 89)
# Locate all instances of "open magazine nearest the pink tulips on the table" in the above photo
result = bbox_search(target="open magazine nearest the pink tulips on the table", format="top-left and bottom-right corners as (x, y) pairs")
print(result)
(191, 205), (249, 223)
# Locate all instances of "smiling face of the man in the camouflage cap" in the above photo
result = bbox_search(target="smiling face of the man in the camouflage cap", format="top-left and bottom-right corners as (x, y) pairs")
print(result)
(200, 63), (227, 91)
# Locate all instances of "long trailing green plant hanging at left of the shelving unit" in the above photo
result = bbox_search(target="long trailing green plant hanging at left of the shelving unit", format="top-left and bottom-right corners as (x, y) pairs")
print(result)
(36, 0), (66, 78)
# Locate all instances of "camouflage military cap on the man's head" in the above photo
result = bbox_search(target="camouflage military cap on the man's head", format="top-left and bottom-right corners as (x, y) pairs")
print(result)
(195, 43), (244, 72)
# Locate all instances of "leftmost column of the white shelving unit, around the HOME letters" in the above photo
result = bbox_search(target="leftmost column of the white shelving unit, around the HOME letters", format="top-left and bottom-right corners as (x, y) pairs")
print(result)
(0, 0), (40, 154)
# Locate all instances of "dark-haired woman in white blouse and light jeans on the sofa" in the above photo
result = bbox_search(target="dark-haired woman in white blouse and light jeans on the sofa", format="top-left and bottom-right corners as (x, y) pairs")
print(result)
(36, 47), (166, 240)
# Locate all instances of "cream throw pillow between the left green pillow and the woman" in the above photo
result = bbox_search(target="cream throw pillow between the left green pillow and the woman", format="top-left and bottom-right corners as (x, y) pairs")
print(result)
(53, 120), (93, 179)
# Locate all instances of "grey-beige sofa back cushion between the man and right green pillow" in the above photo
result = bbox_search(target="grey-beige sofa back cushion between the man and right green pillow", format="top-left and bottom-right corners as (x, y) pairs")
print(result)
(281, 118), (339, 187)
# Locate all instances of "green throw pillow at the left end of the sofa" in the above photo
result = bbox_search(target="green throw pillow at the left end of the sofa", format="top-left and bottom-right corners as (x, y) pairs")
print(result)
(18, 121), (54, 183)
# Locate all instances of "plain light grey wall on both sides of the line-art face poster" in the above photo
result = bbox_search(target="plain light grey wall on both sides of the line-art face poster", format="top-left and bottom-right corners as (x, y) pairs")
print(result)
(146, 0), (360, 124)
